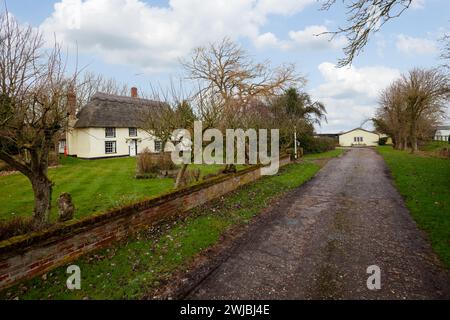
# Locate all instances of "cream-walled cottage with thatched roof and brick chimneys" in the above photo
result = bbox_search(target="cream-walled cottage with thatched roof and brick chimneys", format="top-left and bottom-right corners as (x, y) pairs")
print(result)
(59, 88), (168, 159)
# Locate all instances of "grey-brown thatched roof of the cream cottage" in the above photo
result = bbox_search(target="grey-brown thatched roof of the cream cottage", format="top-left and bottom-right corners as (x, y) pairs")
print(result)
(75, 92), (162, 128)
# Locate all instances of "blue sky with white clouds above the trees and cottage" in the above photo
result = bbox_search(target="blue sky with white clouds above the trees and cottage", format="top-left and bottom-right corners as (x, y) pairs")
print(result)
(6, 0), (450, 133)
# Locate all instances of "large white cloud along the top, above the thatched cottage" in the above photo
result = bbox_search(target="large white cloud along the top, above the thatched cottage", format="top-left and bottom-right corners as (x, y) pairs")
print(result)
(41, 0), (314, 70)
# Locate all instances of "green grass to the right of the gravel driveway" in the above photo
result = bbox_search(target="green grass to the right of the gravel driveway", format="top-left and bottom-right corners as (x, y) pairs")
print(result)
(378, 146), (450, 267)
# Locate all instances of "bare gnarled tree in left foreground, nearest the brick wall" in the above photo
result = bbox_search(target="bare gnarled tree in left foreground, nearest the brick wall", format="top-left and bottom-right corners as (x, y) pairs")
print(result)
(0, 12), (74, 228)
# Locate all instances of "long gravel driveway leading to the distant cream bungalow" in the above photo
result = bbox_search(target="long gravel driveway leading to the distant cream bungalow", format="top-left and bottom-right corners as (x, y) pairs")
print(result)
(187, 148), (450, 299)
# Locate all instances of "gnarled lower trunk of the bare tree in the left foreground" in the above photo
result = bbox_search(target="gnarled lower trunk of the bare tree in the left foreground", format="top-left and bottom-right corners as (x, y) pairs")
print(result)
(30, 174), (52, 229)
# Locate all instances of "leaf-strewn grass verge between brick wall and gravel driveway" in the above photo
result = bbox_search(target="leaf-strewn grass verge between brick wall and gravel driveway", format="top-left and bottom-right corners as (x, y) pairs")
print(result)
(0, 152), (341, 299)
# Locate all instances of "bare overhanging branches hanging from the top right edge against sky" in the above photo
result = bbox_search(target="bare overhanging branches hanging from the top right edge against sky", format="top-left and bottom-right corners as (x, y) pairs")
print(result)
(322, 0), (413, 67)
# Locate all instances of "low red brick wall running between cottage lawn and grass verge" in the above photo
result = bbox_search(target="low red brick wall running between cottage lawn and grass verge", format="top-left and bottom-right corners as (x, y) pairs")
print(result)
(0, 157), (290, 290)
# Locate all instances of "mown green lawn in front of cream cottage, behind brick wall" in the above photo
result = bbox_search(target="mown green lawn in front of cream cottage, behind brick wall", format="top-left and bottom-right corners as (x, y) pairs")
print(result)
(0, 157), (227, 220)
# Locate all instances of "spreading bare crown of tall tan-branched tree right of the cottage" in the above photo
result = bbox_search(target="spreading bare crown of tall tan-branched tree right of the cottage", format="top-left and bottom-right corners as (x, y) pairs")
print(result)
(182, 38), (305, 127)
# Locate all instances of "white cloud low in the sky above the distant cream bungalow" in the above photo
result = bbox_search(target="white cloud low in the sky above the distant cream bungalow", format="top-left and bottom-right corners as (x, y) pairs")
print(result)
(311, 62), (400, 132)
